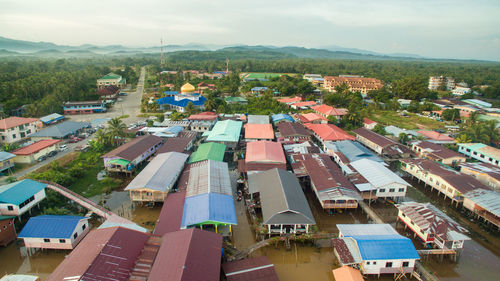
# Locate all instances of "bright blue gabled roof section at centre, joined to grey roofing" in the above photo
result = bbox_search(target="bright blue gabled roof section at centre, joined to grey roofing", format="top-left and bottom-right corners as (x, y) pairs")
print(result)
(181, 193), (237, 228)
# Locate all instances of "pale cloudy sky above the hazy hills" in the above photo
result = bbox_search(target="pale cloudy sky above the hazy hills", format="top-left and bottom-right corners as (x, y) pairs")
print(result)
(0, 0), (500, 61)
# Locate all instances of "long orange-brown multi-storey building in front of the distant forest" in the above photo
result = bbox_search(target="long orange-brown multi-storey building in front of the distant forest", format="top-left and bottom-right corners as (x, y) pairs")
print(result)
(324, 75), (384, 94)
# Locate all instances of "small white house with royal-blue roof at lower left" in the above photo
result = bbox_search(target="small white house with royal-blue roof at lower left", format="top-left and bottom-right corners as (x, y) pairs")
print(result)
(18, 215), (90, 250)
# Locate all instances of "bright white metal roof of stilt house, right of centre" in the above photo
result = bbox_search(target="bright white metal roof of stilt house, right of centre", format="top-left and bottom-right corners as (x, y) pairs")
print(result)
(351, 159), (410, 188)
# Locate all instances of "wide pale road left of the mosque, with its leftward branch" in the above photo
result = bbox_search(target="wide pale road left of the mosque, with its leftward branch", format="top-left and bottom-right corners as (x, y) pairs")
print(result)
(66, 66), (146, 126)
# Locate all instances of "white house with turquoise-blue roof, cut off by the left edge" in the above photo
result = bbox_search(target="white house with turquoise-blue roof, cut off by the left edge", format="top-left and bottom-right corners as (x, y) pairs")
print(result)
(0, 179), (47, 216)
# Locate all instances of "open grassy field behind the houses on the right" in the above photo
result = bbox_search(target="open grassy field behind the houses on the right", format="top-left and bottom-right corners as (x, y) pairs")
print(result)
(368, 110), (448, 130)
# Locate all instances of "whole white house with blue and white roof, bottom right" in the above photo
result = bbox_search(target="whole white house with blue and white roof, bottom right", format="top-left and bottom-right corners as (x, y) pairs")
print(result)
(332, 224), (420, 275)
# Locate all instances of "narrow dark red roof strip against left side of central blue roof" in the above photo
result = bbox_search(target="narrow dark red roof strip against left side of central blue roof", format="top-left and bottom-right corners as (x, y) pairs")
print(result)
(153, 190), (186, 236)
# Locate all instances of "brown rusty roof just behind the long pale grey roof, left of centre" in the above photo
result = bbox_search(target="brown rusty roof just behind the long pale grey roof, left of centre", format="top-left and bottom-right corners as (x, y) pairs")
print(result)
(102, 135), (163, 161)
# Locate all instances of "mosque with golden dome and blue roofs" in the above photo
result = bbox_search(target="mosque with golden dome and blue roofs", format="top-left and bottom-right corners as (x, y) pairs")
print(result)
(156, 83), (207, 113)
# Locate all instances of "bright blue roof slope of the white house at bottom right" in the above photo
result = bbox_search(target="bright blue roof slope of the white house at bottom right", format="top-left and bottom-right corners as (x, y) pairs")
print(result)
(350, 234), (420, 260)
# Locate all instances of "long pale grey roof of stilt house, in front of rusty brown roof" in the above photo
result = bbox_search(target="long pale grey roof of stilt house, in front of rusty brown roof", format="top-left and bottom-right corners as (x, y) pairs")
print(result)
(125, 152), (188, 192)
